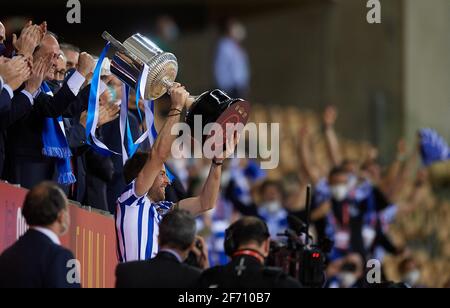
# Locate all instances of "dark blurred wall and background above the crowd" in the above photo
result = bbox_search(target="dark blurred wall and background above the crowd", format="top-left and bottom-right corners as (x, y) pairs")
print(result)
(0, 0), (450, 159)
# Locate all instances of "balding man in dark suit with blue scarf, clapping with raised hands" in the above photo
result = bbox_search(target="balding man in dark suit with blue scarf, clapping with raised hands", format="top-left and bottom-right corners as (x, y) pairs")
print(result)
(7, 34), (94, 188)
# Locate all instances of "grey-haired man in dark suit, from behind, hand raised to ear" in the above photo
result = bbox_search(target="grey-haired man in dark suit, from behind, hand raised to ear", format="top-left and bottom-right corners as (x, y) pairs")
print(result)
(116, 210), (208, 288)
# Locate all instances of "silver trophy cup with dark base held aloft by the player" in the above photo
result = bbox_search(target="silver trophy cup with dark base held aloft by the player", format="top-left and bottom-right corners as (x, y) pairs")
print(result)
(102, 32), (250, 142)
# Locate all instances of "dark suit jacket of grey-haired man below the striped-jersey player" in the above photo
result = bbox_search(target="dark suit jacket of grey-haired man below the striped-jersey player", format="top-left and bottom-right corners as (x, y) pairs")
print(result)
(116, 252), (201, 288)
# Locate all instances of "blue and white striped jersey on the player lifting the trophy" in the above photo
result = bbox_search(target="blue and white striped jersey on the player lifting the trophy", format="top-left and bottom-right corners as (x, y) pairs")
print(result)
(115, 181), (174, 262)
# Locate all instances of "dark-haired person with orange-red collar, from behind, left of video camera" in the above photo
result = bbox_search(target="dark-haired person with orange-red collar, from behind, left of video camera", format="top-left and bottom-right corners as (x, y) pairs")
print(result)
(200, 216), (301, 288)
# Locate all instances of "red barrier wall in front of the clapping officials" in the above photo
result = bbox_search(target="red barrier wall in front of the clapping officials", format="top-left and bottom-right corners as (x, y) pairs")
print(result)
(0, 182), (117, 288)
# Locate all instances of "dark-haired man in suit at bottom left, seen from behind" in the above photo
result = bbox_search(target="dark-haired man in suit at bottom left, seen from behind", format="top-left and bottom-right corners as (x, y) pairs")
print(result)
(0, 182), (80, 288)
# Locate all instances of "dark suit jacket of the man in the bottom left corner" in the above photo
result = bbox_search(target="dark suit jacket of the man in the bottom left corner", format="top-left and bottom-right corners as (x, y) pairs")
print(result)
(0, 229), (80, 288)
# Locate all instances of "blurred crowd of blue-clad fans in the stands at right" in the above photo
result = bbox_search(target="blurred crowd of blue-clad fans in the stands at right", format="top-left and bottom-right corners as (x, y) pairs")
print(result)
(190, 105), (450, 287)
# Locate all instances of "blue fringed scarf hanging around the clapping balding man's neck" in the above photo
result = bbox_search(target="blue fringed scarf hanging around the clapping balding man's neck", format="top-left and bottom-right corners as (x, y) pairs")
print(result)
(41, 82), (76, 185)
